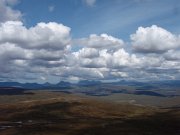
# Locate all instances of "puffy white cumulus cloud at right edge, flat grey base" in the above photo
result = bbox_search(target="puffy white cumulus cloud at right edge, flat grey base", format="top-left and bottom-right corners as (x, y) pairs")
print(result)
(131, 25), (180, 53)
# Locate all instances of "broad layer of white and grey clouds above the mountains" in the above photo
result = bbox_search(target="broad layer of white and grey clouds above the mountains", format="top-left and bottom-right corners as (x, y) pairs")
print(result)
(0, 21), (180, 82)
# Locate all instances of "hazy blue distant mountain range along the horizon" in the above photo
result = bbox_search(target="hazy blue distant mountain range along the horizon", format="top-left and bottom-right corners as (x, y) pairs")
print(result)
(0, 80), (180, 90)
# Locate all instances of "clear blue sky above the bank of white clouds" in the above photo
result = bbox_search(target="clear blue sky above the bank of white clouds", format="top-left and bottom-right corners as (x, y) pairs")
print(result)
(16, 0), (180, 40)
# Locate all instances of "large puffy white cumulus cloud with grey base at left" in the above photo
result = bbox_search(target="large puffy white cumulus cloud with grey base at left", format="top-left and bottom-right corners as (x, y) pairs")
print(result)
(0, 21), (71, 49)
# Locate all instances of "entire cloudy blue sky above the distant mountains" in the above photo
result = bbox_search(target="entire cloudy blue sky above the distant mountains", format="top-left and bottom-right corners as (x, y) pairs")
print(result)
(0, 0), (180, 83)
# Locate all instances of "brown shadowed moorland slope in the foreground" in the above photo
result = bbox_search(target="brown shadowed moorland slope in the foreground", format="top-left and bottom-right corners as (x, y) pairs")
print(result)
(0, 91), (180, 135)
